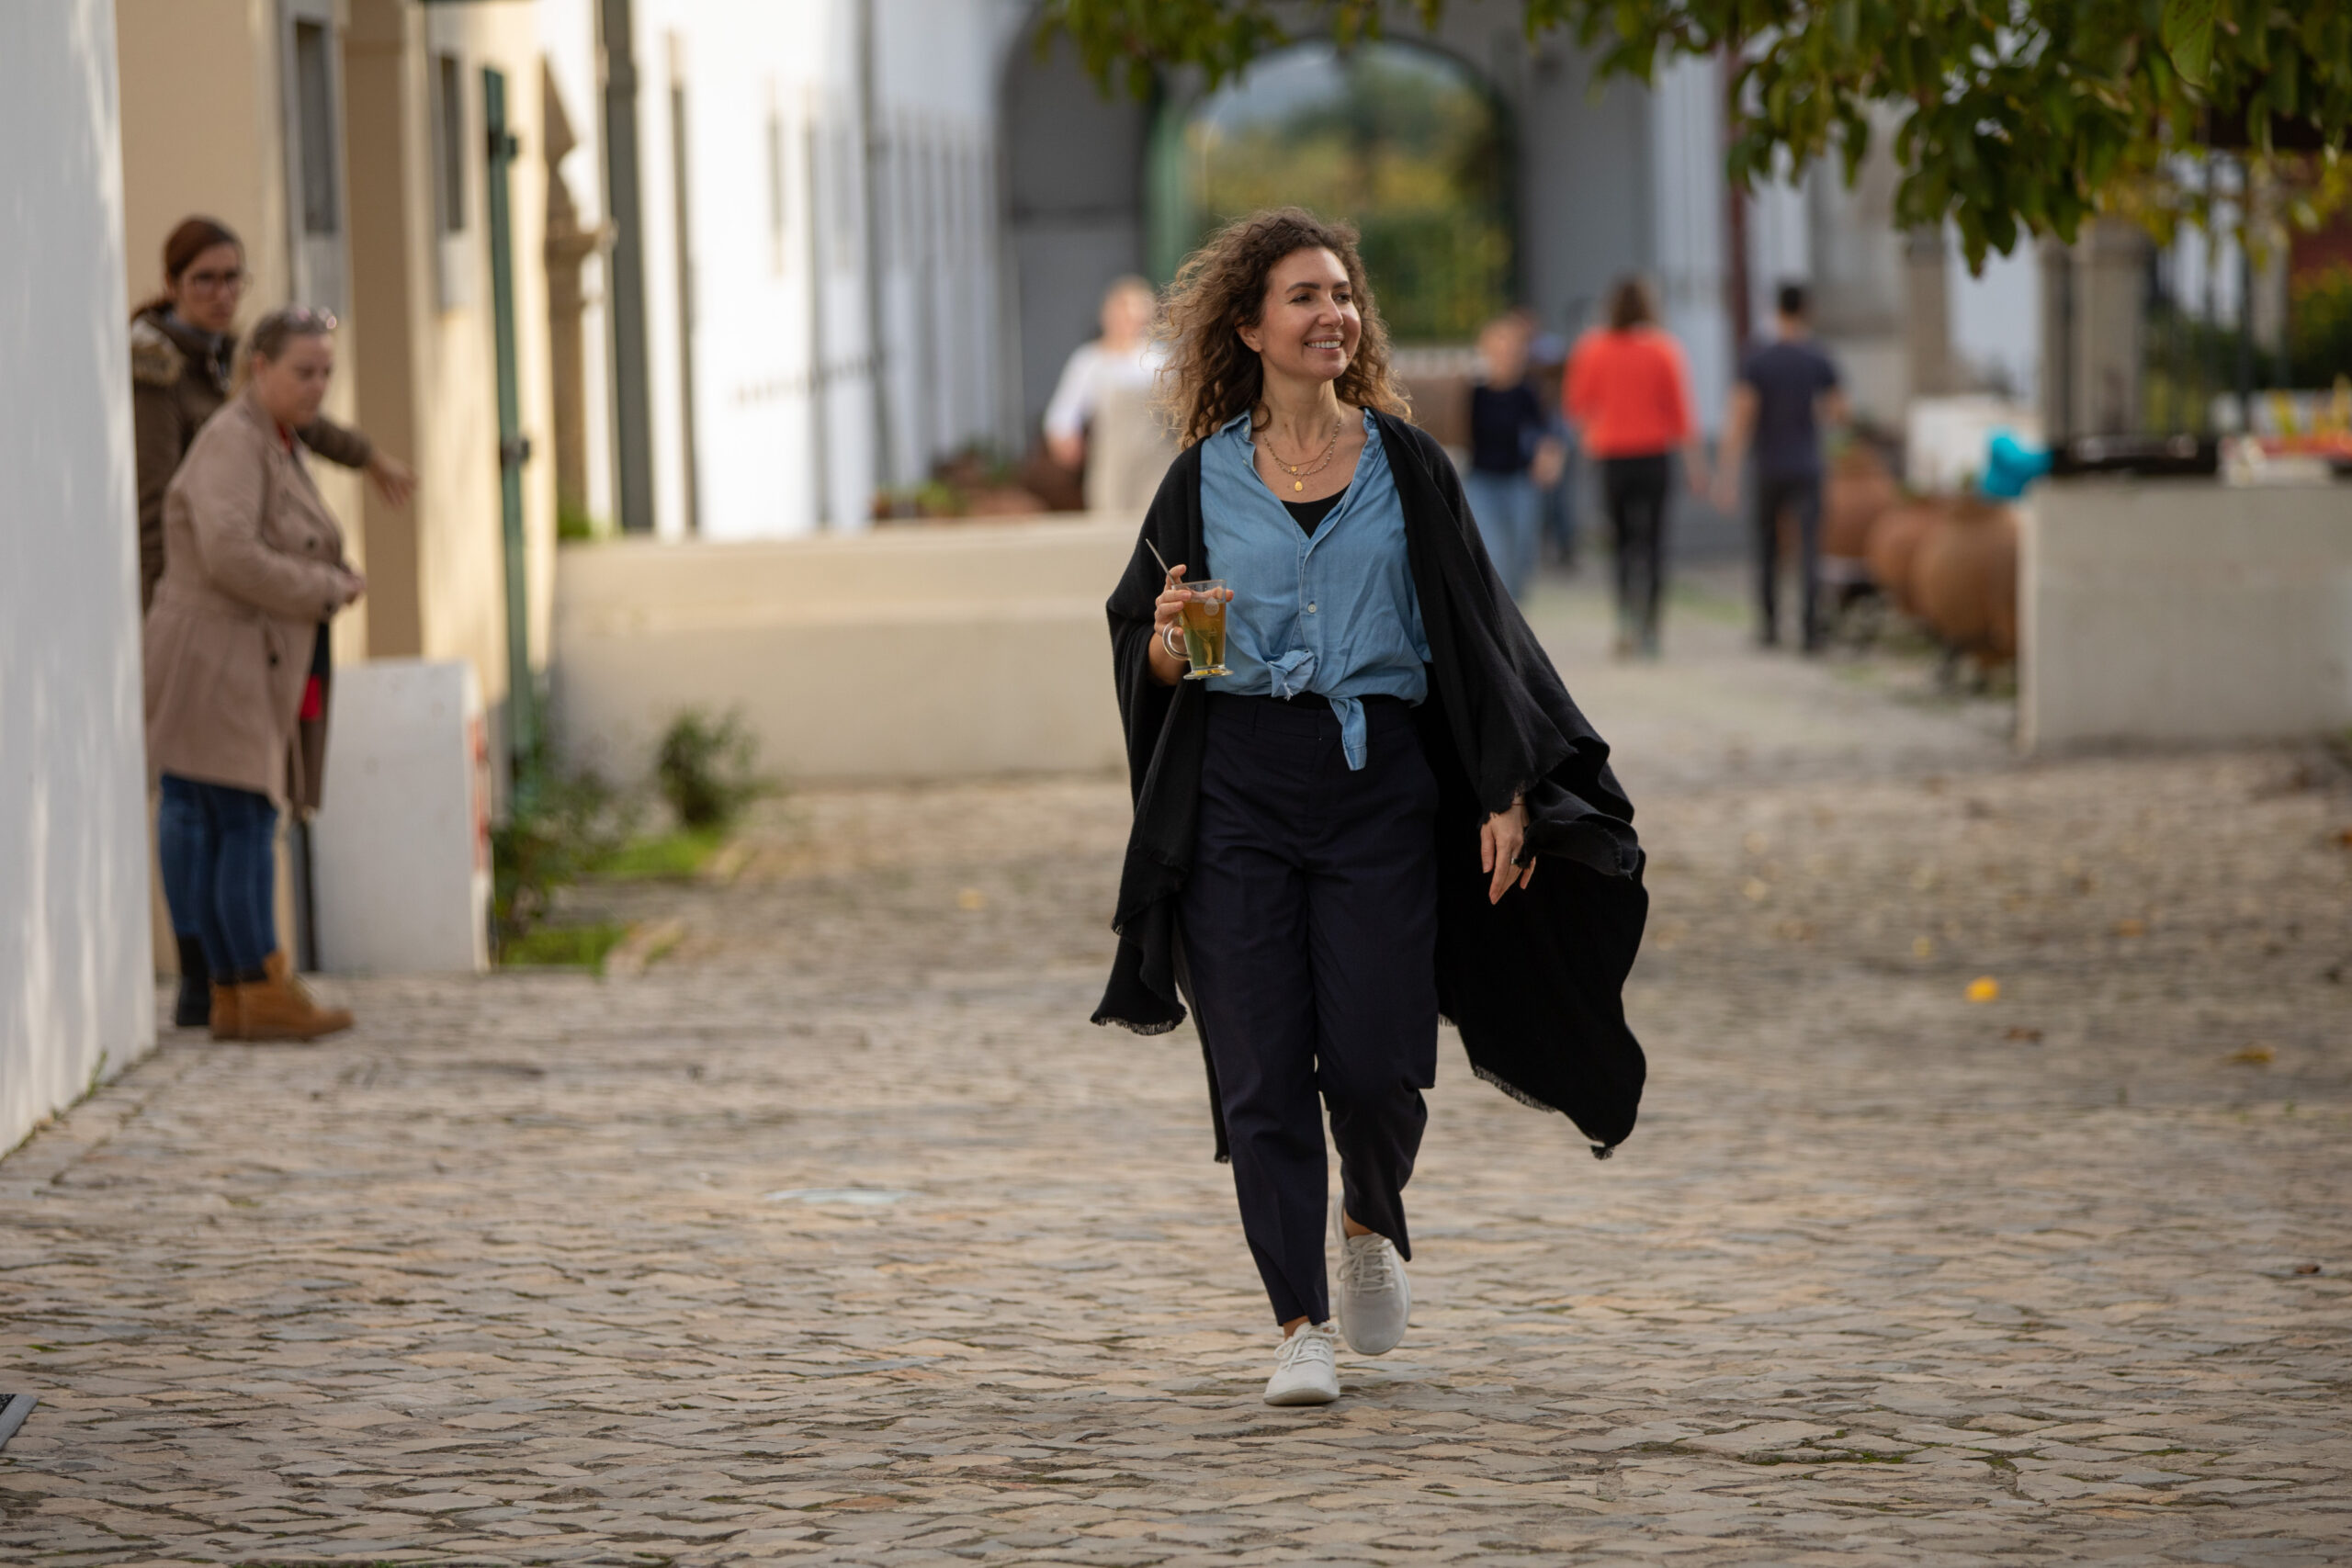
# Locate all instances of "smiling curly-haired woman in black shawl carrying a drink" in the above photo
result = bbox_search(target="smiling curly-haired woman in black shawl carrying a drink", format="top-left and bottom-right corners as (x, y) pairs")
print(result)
(1093, 207), (1646, 1405)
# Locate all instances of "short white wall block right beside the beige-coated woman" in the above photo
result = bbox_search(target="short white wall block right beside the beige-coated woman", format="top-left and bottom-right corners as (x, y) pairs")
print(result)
(311, 659), (489, 976)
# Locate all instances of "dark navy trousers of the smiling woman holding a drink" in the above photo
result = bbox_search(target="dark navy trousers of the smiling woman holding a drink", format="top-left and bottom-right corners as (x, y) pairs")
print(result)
(1183, 694), (1437, 1324)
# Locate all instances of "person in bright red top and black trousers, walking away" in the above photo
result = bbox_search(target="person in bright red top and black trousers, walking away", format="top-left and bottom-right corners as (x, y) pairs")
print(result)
(1564, 277), (1708, 659)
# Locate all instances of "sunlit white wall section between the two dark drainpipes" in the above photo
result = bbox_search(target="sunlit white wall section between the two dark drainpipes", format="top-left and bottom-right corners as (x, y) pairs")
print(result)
(635, 0), (873, 538)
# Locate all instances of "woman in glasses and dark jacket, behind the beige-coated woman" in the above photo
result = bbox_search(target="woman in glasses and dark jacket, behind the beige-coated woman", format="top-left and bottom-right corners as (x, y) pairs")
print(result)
(131, 219), (416, 1030)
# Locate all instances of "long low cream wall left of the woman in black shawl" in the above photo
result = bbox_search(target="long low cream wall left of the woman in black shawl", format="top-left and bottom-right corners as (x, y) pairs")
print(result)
(550, 517), (1136, 778)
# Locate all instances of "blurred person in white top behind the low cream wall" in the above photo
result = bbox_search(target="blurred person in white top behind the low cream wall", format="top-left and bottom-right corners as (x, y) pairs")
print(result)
(1045, 277), (1176, 513)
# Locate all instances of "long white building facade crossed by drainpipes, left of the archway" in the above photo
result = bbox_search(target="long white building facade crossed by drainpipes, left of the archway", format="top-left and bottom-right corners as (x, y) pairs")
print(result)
(576, 0), (1002, 541)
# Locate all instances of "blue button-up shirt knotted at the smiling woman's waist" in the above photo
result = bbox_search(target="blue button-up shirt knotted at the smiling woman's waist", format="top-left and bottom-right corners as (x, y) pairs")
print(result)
(1200, 412), (1430, 769)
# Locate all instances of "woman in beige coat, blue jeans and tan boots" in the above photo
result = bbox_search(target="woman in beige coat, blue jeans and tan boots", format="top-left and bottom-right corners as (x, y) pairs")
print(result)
(146, 306), (365, 1039)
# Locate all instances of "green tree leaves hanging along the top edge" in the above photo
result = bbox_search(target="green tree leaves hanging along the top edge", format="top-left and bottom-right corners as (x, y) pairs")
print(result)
(1046, 0), (2352, 265)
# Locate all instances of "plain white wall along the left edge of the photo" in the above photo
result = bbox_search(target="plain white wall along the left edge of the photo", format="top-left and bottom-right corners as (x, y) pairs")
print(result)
(0, 0), (155, 1149)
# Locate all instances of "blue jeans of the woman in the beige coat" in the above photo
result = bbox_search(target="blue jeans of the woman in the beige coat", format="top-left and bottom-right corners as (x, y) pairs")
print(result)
(155, 773), (277, 983)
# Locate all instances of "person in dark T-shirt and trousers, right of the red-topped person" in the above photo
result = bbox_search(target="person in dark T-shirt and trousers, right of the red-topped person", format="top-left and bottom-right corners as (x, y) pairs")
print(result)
(1714, 282), (1847, 653)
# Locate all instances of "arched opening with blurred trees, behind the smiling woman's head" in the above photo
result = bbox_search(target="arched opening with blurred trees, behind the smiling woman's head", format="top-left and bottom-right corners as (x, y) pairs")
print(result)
(1148, 40), (1517, 344)
